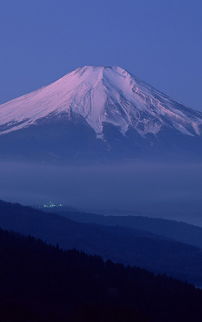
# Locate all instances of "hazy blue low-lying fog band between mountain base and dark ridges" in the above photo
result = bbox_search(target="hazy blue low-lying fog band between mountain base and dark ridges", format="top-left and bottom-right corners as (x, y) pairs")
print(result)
(0, 162), (202, 226)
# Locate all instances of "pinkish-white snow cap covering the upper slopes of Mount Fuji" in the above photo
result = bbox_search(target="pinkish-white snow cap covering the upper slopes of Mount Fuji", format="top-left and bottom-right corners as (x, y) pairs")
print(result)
(0, 66), (202, 138)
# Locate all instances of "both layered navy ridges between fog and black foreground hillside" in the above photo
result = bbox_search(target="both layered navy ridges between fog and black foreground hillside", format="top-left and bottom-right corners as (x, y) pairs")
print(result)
(0, 202), (202, 286)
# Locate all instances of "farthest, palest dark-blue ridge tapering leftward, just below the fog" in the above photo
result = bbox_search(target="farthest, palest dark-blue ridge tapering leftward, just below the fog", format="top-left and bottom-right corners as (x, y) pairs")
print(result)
(49, 208), (202, 248)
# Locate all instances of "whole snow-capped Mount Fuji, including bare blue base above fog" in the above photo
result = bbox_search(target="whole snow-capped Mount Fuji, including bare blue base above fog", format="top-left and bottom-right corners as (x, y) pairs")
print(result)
(0, 66), (202, 162)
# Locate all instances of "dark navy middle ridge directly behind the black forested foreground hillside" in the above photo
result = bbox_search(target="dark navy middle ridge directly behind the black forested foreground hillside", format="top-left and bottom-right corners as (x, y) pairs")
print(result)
(0, 202), (202, 285)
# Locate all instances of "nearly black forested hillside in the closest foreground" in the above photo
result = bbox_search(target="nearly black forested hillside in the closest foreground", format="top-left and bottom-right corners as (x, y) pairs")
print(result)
(0, 230), (202, 322)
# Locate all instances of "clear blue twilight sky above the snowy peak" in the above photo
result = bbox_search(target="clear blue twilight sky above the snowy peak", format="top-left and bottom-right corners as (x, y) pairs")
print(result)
(0, 0), (202, 110)
